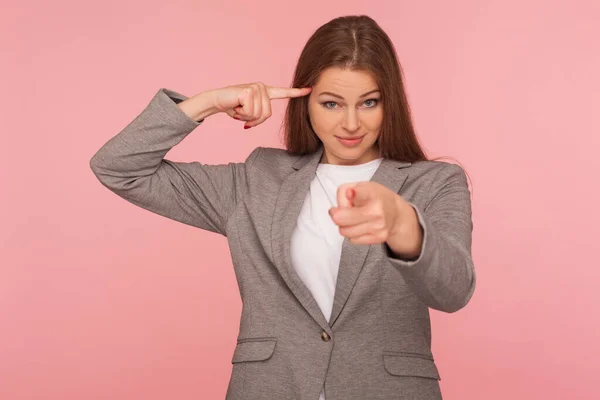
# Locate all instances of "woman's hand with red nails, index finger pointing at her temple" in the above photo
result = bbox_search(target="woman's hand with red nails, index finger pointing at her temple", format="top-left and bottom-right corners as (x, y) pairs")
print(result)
(210, 82), (312, 128)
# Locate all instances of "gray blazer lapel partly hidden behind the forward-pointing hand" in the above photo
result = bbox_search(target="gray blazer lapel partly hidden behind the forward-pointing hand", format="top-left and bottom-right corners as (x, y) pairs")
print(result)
(329, 158), (411, 326)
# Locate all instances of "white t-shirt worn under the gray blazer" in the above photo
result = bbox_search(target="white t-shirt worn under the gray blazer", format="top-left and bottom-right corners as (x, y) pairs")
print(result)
(290, 158), (383, 400)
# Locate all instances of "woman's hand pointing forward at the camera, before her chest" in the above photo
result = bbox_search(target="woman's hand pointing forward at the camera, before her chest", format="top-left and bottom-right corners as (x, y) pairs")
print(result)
(329, 181), (423, 259)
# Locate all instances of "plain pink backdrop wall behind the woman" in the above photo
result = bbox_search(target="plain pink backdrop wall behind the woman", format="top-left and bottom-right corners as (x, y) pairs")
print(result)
(0, 0), (600, 400)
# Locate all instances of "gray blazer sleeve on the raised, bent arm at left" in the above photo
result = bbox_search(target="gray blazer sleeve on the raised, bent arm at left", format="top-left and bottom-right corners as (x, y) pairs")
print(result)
(90, 88), (261, 236)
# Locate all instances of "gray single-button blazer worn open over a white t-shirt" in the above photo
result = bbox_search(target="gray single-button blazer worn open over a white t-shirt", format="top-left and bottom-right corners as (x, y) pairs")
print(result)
(90, 88), (475, 400)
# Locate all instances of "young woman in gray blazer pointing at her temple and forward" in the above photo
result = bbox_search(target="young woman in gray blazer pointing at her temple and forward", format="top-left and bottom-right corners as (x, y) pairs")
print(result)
(90, 16), (475, 400)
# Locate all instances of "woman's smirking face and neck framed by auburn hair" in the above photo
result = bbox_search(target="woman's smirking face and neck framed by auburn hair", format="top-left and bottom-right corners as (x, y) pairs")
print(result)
(308, 67), (383, 165)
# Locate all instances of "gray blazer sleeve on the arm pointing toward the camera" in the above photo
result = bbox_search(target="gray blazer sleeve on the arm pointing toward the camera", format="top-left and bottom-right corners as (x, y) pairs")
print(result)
(386, 163), (475, 313)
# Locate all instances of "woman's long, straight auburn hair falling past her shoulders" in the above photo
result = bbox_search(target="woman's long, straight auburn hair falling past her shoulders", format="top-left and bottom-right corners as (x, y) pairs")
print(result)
(283, 15), (428, 162)
